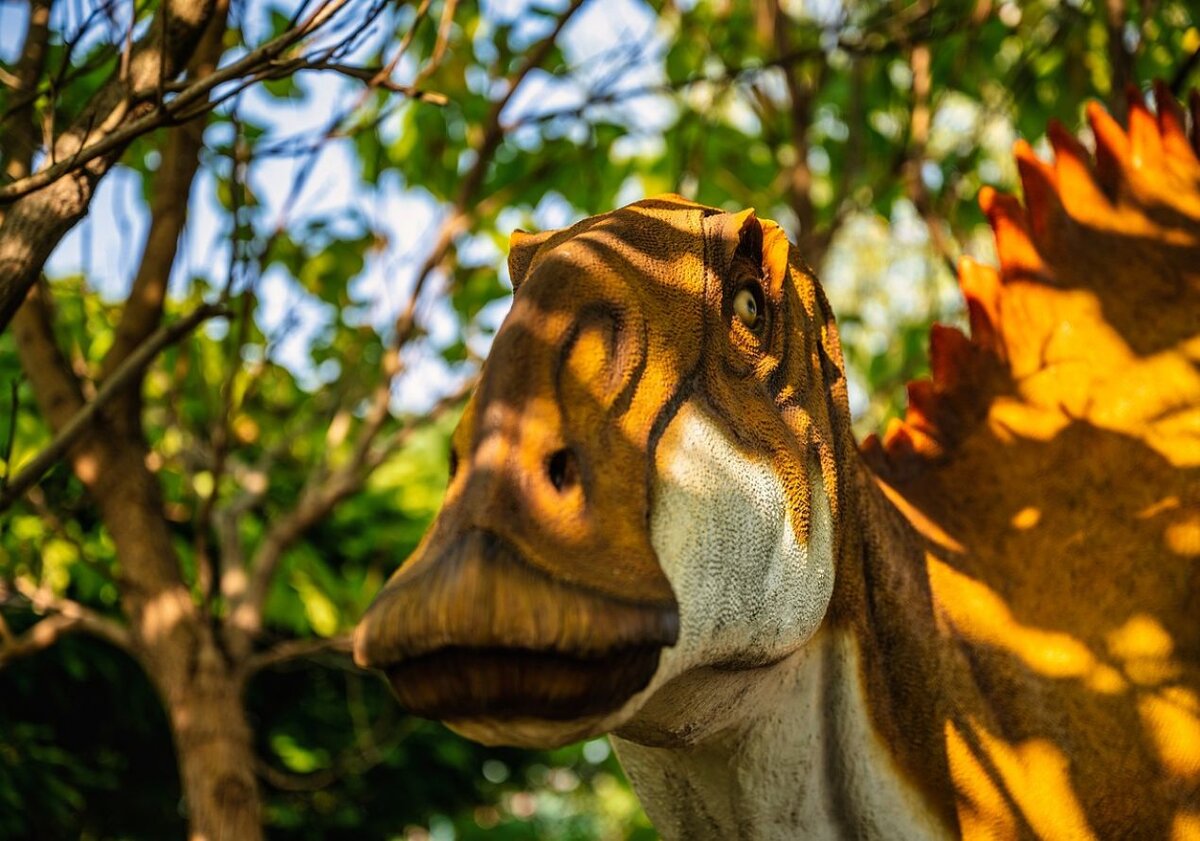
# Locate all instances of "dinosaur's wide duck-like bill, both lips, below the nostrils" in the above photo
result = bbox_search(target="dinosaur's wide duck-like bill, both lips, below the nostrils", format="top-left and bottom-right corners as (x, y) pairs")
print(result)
(355, 529), (678, 746)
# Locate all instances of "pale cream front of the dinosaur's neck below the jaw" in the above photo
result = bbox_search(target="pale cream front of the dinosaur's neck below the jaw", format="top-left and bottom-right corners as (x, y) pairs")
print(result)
(613, 629), (947, 839)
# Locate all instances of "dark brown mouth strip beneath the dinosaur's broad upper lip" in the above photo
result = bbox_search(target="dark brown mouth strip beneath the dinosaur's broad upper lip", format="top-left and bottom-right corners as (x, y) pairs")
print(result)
(384, 645), (661, 721)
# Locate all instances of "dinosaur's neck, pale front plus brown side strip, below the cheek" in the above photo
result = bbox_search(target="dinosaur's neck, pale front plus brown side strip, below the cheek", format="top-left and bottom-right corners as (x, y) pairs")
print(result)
(613, 457), (954, 839)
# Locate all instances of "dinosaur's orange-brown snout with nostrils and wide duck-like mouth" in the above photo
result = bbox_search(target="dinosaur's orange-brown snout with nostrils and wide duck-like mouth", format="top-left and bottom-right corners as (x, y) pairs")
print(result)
(355, 290), (679, 725)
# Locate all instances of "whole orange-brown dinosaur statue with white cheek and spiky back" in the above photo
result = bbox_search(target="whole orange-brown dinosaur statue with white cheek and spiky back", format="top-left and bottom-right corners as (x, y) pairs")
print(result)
(355, 90), (1200, 841)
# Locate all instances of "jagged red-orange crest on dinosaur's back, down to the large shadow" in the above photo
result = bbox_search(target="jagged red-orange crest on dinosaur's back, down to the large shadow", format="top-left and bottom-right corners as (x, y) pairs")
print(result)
(872, 83), (1200, 473)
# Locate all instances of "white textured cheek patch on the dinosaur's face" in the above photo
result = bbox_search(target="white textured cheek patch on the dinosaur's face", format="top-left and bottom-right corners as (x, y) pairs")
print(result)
(650, 403), (833, 671)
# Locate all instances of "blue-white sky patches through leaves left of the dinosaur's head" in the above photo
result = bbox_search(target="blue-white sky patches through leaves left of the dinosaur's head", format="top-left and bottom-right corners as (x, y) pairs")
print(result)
(0, 0), (676, 412)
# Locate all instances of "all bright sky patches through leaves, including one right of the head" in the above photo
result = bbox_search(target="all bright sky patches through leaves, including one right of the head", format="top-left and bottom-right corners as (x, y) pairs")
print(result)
(0, 0), (969, 412)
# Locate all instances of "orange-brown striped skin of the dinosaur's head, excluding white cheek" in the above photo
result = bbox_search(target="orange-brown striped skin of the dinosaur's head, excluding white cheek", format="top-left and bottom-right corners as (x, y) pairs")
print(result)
(356, 197), (834, 734)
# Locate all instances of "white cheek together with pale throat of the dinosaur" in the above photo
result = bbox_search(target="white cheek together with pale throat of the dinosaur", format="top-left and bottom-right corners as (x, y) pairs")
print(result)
(613, 403), (944, 841)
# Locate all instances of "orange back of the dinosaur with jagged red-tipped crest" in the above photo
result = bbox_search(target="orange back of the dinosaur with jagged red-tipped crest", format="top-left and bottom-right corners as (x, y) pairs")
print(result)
(863, 88), (1200, 837)
